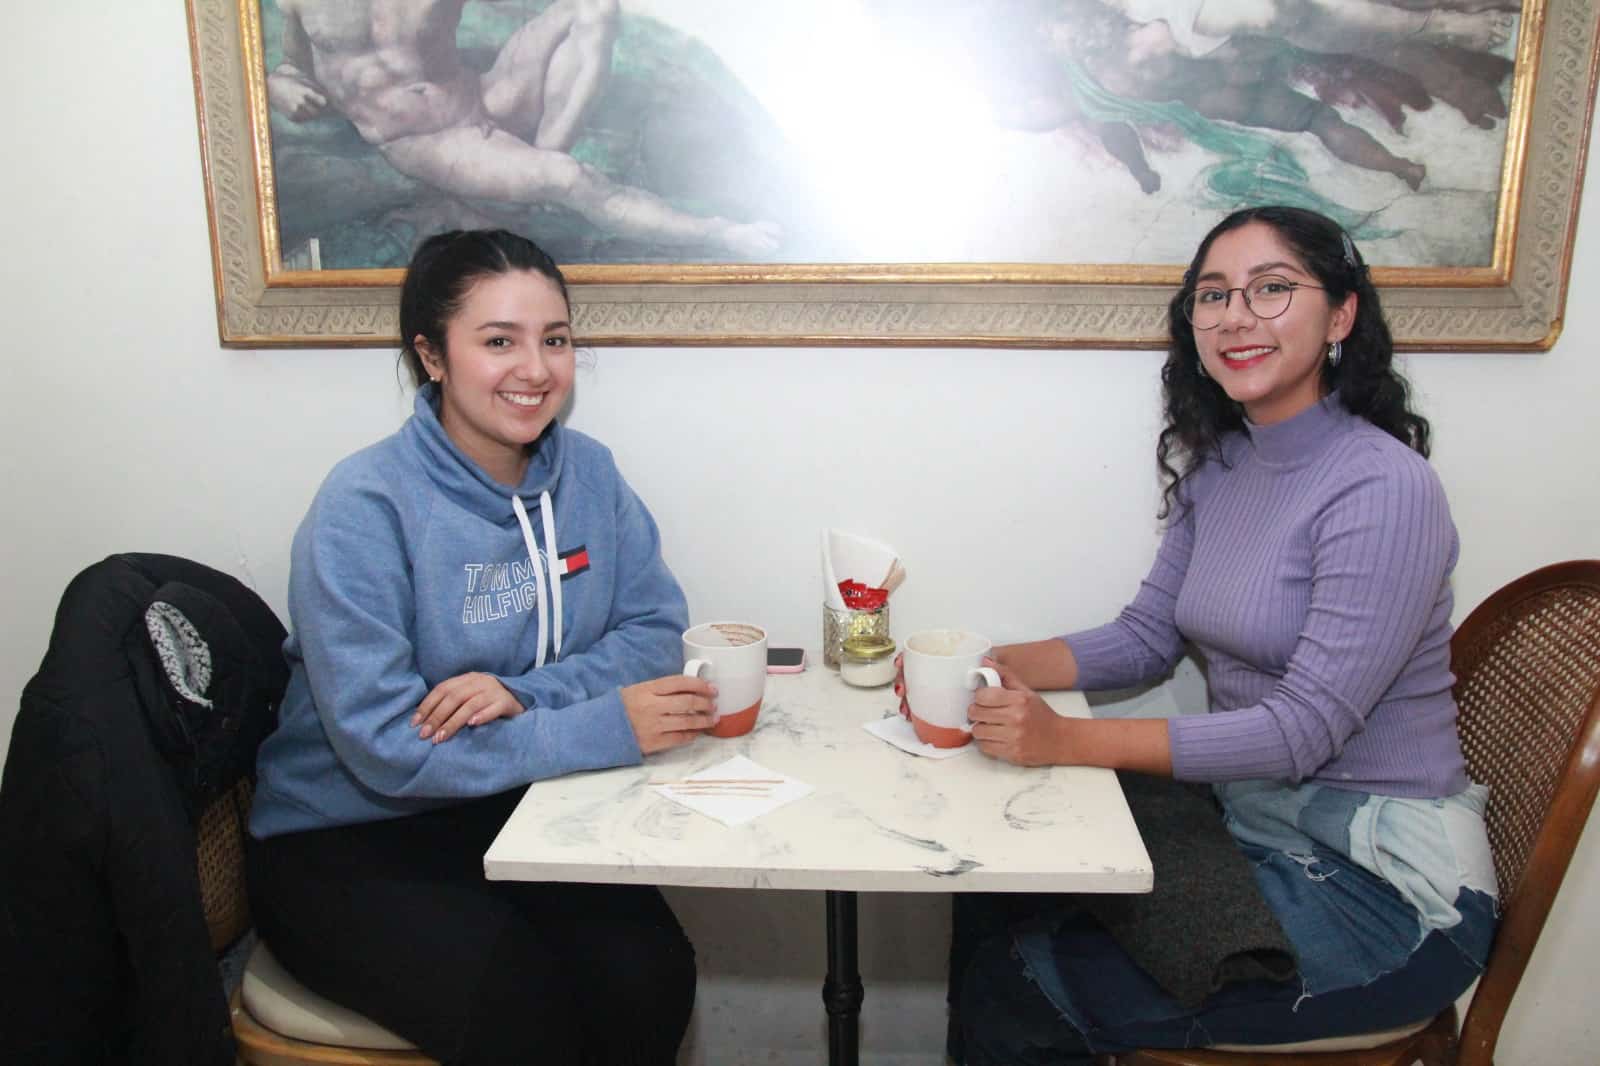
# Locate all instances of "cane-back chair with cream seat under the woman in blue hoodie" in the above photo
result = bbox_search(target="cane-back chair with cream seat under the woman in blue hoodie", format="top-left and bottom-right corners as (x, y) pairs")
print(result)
(197, 779), (438, 1066)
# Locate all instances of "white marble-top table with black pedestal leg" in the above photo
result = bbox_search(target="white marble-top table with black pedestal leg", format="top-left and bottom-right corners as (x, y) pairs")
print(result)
(483, 656), (1152, 1063)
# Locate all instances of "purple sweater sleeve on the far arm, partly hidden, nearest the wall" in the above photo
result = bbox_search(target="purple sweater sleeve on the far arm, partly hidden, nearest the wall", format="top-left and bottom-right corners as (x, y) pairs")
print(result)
(1062, 509), (1194, 690)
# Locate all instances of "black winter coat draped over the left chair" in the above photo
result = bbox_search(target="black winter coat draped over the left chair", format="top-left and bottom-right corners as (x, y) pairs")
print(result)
(0, 554), (288, 1066)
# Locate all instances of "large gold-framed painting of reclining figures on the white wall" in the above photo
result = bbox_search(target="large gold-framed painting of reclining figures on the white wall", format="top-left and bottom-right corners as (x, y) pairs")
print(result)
(189, 0), (1600, 351)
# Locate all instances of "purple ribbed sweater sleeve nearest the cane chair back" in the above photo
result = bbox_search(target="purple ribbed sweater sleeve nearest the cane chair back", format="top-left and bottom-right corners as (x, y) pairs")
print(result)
(1170, 453), (1456, 783)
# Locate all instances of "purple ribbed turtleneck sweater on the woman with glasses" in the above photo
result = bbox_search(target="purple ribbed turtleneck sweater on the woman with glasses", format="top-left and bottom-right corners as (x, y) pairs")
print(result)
(1064, 395), (1467, 797)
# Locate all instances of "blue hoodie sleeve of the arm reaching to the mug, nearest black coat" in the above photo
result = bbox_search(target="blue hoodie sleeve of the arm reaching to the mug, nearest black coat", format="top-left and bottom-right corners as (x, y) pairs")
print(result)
(290, 479), (640, 799)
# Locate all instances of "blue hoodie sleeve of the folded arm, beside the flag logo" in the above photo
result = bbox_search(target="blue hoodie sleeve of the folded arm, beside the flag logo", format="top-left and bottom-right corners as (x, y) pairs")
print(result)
(501, 482), (688, 713)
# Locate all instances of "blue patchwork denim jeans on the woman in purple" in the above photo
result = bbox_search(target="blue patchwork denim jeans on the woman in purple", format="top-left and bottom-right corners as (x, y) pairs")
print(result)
(950, 783), (1496, 1066)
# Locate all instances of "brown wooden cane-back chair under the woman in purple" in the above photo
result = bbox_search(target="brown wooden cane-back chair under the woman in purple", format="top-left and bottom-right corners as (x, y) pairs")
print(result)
(1115, 559), (1600, 1066)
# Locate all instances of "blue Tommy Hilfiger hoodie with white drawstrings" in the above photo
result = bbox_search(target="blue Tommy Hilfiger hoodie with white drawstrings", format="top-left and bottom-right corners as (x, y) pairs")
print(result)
(250, 384), (688, 837)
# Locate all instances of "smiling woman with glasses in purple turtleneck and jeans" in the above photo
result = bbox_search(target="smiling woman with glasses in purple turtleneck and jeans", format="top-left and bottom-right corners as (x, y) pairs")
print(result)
(950, 206), (1496, 1066)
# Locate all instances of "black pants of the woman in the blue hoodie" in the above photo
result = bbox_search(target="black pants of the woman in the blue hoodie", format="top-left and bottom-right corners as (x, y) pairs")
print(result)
(246, 789), (694, 1066)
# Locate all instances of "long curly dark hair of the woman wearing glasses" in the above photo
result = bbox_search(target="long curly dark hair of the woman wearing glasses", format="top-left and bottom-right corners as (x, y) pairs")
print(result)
(1155, 206), (1429, 519)
